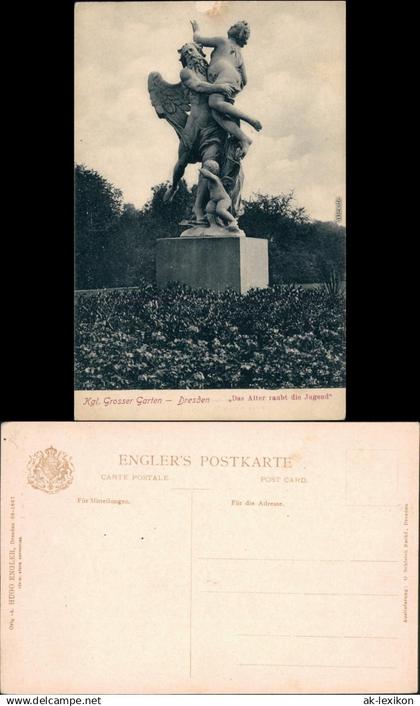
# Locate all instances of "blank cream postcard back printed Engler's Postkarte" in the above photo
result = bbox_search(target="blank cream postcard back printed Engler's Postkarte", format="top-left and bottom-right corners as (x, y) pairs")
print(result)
(1, 422), (418, 693)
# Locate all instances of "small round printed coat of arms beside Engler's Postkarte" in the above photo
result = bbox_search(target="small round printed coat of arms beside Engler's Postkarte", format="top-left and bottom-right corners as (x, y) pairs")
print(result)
(28, 446), (74, 493)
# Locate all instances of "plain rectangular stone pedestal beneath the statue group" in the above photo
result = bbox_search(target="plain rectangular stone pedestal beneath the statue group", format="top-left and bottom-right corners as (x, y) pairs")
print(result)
(156, 235), (268, 294)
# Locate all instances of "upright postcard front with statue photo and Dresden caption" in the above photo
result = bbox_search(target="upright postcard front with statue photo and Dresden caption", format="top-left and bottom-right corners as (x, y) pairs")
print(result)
(74, 0), (346, 421)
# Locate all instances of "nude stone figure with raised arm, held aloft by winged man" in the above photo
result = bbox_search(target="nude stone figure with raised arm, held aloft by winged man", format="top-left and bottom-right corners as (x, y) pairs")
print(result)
(191, 20), (262, 157)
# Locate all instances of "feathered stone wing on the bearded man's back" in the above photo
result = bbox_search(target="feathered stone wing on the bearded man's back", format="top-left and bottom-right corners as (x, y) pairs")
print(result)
(147, 71), (191, 138)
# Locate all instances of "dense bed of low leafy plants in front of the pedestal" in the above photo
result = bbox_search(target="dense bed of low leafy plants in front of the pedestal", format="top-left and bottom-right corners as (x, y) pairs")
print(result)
(75, 281), (345, 390)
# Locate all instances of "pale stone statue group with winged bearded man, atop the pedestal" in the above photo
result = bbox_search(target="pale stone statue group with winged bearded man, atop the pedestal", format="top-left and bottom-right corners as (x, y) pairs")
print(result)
(148, 17), (261, 236)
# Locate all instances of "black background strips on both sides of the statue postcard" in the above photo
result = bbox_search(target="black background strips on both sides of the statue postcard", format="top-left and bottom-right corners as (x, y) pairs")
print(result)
(1, 0), (419, 421)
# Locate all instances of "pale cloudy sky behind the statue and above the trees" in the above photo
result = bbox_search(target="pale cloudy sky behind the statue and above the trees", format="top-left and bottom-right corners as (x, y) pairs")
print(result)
(75, 0), (345, 221)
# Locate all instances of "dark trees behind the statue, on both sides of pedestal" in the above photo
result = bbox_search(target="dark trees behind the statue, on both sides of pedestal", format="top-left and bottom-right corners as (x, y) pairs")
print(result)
(75, 165), (346, 289)
